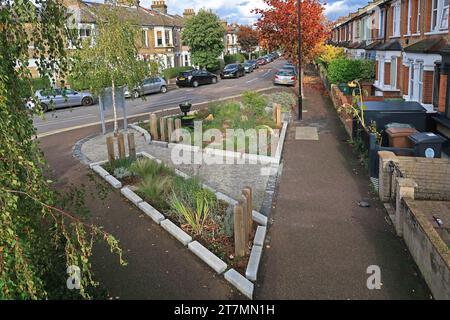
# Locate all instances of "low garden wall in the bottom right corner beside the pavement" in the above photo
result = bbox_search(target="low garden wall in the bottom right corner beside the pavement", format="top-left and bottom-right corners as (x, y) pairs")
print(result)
(401, 198), (450, 300)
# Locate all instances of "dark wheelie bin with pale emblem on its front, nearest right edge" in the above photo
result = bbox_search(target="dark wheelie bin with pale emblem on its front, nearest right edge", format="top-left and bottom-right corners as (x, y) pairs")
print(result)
(409, 132), (447, 158)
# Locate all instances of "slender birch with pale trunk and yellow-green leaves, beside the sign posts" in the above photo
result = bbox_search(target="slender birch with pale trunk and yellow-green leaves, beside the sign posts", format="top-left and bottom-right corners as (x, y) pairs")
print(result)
(72, 4), (151, 135)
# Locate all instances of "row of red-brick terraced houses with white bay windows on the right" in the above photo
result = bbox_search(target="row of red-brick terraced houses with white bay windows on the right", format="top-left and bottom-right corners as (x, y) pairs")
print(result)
(331, 0), (450, 141)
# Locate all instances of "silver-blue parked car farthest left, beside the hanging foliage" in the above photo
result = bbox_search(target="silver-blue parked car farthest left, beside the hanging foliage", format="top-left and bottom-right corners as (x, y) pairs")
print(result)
(27, 89), (96, 112)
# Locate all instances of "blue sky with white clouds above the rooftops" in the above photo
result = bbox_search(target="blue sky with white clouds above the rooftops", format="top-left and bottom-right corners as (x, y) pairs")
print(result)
(141, 0), (369, 24)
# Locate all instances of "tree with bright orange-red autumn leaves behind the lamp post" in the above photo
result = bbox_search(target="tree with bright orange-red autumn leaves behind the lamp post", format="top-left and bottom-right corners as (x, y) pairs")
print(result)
(254, 0), (328, 62)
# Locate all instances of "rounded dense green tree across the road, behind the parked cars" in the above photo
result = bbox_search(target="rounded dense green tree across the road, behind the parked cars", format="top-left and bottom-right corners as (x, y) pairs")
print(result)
(182, 10), (226, 69)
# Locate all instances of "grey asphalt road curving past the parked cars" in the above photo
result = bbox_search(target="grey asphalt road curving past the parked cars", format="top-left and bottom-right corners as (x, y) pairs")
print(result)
(34, 59), (285, 135)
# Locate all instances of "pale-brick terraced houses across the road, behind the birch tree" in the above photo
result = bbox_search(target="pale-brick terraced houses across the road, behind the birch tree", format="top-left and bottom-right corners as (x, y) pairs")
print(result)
(29, 0), (195, 74)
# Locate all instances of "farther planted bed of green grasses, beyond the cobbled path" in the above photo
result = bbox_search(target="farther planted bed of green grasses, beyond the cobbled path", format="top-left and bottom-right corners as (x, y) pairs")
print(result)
(139, 91), (296, 156)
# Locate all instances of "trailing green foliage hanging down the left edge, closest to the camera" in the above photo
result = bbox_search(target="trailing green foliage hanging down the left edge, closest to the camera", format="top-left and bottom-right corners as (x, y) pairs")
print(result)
(0, 0), (122, 300)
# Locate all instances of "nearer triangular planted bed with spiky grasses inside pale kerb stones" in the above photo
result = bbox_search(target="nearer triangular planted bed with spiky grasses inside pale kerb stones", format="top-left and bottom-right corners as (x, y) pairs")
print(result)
(103, 156), (254, 273)
